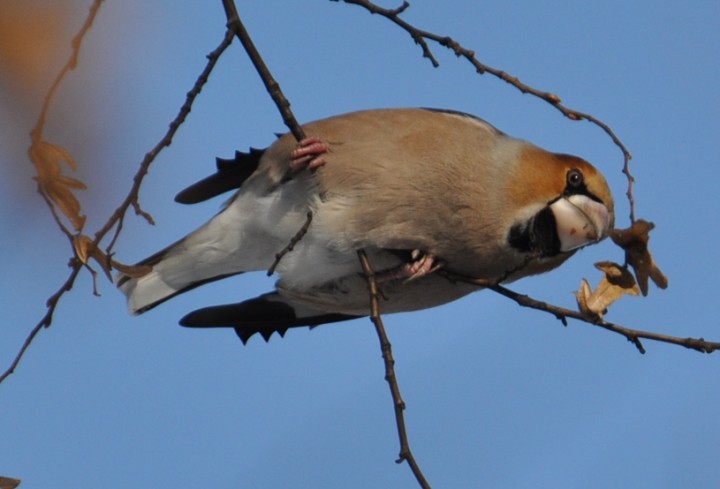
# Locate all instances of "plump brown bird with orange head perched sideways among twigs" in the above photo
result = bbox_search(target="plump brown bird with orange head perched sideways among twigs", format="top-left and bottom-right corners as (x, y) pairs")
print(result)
(117, 108), (614, 343)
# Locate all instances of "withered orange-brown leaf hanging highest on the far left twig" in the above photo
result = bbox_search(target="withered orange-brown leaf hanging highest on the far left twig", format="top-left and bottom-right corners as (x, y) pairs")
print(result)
(28, 140), (86, 231)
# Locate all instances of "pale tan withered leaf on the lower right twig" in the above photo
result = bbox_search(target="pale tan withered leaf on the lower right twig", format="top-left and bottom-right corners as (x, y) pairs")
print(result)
(575, 262), (639, 319)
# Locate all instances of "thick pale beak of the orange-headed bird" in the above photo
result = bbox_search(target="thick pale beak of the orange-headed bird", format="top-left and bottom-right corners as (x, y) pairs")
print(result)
(550, 195), (610, 251)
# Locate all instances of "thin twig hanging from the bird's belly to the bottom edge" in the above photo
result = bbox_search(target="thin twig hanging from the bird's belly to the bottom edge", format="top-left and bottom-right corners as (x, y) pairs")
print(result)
(357, 249), (430, 488)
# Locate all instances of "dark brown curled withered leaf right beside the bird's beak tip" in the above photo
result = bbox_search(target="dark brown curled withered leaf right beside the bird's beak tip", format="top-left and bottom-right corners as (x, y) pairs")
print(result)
(610, 219), (668, 295)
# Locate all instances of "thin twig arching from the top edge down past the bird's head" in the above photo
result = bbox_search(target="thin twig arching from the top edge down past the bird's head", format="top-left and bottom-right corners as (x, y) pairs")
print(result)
(331, 0), (635, 222)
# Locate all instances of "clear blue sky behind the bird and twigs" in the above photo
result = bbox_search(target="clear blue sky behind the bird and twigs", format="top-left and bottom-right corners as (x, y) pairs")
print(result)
(0, 0), (720, 489)
